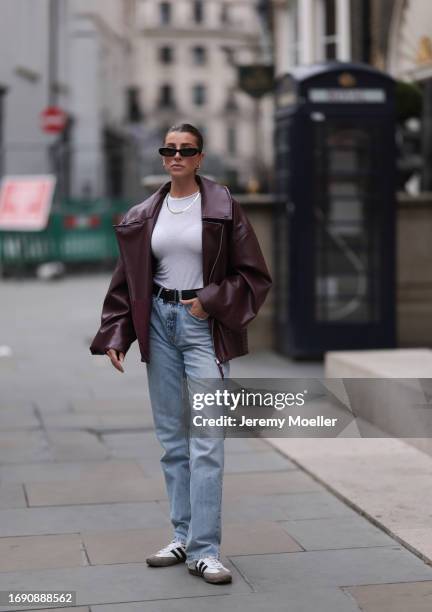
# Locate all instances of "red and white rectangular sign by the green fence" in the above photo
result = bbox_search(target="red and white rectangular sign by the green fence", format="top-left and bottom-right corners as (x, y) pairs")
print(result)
(0, 174), (56, 231)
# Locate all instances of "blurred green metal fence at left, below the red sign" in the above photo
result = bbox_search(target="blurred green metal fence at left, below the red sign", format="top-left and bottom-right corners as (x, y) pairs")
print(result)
(0, 199), (130, 270)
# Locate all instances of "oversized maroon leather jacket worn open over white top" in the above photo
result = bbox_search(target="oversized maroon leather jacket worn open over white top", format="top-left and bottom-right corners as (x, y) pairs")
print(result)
(90, 175), (272, 369)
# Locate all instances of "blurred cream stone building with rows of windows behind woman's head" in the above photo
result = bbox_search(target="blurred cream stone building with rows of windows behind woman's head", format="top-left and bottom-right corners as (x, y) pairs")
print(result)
(137, 0), (273, 189)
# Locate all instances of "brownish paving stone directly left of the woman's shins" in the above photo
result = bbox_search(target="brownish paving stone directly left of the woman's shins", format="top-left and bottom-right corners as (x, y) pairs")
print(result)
(25, 475), (166, 506)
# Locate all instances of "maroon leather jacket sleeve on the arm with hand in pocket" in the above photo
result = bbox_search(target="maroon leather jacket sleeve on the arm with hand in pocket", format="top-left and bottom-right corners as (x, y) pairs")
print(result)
(197, 200), (272, 331)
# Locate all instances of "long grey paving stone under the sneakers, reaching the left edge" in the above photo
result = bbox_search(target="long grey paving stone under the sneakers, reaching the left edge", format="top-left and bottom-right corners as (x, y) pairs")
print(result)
(0, 559), (251, 610)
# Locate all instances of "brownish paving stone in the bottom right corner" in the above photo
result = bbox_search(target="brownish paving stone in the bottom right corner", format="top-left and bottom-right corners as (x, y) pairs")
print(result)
(346, 581), (432, 612)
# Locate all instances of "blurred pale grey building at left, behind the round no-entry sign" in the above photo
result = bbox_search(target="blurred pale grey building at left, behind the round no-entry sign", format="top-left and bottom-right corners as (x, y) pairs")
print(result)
(0, 0), (136, 197)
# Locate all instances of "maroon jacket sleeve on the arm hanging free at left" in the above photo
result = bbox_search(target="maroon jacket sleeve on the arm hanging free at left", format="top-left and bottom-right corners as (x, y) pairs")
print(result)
(90, 256), (136, 355)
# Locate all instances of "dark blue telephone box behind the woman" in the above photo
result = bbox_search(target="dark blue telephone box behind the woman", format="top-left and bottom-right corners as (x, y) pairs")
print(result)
(274, 62), (396, 358)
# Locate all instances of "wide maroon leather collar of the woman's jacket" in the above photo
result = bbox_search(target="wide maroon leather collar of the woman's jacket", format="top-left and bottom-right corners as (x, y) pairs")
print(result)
(125, 174), (232, 223)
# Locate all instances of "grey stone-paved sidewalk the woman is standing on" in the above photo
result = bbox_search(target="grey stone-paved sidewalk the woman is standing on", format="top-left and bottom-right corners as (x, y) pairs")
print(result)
(0, 276), (432, 612)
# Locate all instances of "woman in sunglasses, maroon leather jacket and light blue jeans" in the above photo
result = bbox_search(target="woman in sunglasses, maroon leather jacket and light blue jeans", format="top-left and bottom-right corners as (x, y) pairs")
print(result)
(90, 123), (271, 584)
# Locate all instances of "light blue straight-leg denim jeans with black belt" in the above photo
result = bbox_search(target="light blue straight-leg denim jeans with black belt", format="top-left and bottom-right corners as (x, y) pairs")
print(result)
(146, 295), (230, 562)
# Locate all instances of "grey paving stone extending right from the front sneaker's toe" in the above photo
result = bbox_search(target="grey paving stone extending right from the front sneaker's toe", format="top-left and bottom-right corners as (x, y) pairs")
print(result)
(231, 546), (432, 591)
